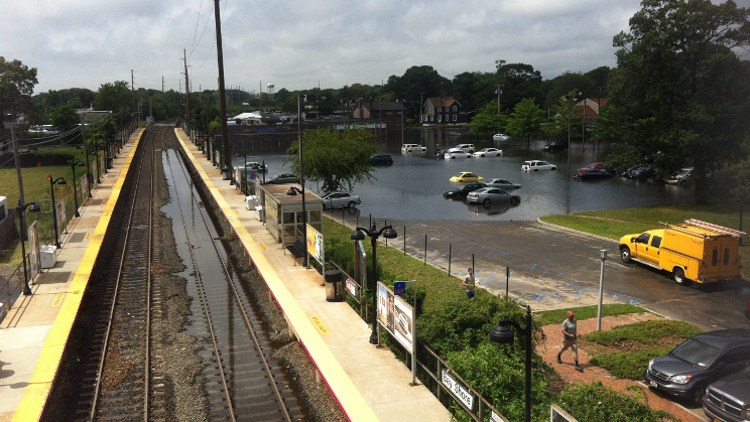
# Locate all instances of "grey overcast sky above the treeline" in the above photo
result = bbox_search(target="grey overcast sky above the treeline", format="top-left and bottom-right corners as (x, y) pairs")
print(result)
(0, 0), (750, 93)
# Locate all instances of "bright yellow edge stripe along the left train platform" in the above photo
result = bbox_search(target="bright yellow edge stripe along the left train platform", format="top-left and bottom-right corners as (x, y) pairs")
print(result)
(12, 128), (144, 422)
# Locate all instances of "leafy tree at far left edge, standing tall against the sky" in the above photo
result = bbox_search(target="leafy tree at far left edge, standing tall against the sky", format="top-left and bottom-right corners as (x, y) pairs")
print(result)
(0, 56), (39, 120)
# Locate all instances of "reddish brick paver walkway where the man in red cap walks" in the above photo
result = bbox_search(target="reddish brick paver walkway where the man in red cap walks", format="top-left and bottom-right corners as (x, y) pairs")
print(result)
(537, 313), (707, 422)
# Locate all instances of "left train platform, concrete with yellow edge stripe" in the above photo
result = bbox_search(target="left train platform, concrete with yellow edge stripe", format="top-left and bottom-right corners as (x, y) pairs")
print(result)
(0, 129), (143, 422)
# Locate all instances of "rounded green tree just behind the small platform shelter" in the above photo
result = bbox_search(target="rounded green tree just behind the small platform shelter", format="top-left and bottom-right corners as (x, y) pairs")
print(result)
(285, 129), (378, 193)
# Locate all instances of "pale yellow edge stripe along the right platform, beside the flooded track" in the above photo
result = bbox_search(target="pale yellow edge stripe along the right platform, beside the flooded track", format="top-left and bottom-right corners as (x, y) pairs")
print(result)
(175, 128), (378, 421)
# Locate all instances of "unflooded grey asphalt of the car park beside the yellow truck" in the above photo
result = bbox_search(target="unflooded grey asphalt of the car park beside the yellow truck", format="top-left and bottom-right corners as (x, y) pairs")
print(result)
(338, 211), (750, 330)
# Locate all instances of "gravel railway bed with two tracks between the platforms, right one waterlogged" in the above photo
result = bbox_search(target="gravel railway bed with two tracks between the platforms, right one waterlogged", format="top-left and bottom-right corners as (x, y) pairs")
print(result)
(44, 126), (304, 421)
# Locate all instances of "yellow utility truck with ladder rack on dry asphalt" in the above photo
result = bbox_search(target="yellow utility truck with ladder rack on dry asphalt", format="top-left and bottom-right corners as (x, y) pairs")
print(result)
(620, 218), (745, 285)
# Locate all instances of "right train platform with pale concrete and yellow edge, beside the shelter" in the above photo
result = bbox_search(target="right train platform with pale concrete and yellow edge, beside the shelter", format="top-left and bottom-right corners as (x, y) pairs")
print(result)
(177, 130), (451, 422)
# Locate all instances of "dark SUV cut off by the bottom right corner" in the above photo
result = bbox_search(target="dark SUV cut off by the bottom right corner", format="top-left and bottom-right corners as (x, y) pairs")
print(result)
(703, 367), (750, 422)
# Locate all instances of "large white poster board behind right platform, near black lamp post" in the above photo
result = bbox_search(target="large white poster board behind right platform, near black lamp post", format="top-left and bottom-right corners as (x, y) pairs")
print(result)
(378, 282), (415, 353)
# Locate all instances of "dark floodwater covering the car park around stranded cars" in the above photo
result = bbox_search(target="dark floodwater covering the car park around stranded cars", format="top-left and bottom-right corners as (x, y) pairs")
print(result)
(233, 130), (692, 221)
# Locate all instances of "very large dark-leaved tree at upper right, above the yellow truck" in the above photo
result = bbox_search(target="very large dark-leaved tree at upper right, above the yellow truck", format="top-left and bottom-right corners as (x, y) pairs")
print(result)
(608, 0), (750, 204)
